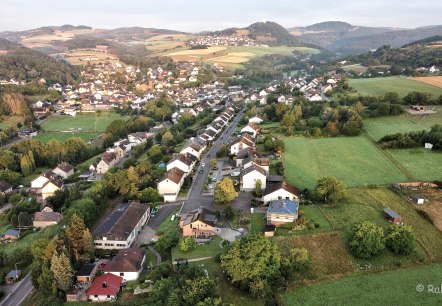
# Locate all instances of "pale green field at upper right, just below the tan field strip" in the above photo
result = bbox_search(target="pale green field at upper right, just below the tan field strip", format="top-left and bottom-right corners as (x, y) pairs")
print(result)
(349, 77), (442, 99)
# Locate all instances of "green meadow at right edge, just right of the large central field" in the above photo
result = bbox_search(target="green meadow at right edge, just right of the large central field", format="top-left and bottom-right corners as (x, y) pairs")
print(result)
(389, 148), (442, 181)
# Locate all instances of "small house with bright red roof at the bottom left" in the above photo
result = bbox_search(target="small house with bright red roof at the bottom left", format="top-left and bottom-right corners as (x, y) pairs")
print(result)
(87, 273), (123, 302)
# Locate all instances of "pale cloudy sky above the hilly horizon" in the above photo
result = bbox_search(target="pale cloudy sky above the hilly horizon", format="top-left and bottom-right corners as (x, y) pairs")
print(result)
(0, 0), (442, 32)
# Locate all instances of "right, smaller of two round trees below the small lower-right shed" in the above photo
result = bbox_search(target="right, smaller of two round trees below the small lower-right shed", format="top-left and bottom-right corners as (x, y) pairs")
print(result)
(386, 225), (416, 255)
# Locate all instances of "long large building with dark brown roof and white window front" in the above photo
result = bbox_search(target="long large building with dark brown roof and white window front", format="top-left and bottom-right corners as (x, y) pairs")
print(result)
(92, 201), (150, 249)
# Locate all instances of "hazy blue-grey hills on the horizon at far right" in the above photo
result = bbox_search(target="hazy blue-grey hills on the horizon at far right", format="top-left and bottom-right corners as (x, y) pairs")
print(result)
(288, 21), (442, 55)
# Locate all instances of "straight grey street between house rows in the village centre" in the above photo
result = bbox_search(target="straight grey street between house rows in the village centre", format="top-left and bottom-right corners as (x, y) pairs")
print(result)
(182, 109), (245, 212)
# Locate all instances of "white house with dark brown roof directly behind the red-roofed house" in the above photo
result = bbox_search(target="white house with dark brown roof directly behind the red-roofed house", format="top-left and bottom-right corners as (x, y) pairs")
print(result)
(103, 248), (146, 281)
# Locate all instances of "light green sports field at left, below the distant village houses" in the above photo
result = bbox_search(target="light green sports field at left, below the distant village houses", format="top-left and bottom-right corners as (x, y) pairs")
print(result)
(41, 112), (121, 133)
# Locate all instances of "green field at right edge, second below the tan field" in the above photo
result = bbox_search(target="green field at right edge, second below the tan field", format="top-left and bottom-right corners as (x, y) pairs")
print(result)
(364, 106), (442, 141)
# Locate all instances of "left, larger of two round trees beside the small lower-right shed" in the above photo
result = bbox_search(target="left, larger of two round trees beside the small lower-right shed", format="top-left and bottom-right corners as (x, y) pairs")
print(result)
(350, 221), (385, 259)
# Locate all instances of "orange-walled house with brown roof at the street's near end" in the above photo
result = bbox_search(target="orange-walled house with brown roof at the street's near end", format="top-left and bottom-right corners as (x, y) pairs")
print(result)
(180, 208), (218, 238)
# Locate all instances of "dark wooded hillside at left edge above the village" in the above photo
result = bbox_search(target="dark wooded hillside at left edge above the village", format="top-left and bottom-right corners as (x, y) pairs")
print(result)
(0, 38), (78, 84)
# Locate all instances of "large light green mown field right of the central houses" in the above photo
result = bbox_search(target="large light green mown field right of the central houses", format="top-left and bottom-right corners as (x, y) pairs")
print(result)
(284, 136), (407, 189)
